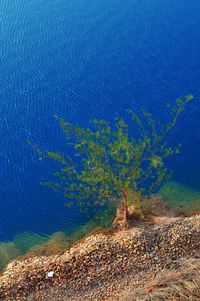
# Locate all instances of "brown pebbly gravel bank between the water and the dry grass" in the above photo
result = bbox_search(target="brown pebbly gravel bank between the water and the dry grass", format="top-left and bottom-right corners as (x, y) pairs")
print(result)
(0, 215), (200, 301)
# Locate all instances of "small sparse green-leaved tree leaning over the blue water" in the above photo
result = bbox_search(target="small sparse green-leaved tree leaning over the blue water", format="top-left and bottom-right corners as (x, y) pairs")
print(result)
(30, 95), (193, 227)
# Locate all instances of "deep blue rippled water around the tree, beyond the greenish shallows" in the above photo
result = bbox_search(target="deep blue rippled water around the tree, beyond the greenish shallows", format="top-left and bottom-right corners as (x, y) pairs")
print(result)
(0, 0), (200, 241)
